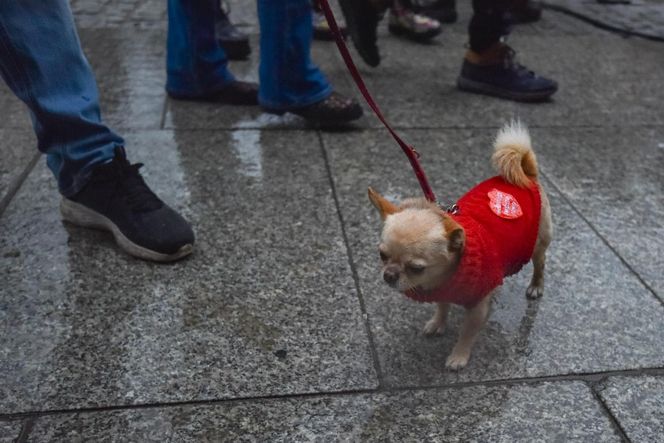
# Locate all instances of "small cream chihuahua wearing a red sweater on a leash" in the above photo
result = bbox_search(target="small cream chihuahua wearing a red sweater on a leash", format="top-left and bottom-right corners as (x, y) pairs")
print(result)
(369, 122), (553, 370)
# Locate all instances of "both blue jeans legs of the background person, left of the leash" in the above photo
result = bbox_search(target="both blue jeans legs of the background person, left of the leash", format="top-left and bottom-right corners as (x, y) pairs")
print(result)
(166, 0), (332, 110)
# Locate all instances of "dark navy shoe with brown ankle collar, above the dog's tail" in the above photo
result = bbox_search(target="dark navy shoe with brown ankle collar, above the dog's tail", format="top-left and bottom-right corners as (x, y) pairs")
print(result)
(457, 45), (558, 102)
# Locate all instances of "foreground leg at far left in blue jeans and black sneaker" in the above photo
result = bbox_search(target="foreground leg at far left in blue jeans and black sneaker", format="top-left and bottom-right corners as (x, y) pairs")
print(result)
(0, 0), (194, 261)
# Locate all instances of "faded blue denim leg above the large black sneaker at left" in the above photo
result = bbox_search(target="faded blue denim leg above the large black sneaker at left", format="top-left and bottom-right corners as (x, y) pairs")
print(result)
(0, 0), (124, 196)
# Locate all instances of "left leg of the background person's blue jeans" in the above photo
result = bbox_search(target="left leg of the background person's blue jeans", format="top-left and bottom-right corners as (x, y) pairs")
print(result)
(166, 0), (235, 97)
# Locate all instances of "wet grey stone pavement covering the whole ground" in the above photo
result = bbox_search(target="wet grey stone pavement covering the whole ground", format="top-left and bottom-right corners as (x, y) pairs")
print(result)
(0, 0), (664, 442)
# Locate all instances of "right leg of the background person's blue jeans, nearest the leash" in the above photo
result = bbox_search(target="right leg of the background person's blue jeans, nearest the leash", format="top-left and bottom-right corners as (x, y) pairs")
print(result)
(258, 0), (333, 110)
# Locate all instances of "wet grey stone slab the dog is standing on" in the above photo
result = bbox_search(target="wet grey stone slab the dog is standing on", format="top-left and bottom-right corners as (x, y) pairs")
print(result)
(324, 129), (664, 386)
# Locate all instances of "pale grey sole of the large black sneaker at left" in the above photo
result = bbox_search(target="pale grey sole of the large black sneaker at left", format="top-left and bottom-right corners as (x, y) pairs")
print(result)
(60, 198), (194, 263)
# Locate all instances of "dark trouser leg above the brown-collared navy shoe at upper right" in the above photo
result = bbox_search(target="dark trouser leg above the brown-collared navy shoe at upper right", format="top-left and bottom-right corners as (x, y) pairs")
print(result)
(468, 0), (513, 52)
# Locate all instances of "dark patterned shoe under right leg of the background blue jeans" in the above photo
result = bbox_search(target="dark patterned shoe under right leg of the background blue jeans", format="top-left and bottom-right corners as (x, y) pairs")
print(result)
(265, 92), (363, 126)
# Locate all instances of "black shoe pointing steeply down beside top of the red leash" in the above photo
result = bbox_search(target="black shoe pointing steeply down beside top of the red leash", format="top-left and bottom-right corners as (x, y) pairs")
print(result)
(339, 0), (384, 67)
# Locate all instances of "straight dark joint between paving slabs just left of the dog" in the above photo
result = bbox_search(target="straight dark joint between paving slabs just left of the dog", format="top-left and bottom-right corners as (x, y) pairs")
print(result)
(316, 131), (383, 389)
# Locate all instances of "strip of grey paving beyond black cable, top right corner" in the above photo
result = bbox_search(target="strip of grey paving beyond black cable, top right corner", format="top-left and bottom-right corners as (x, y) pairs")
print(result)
(544, 0), (664, 39)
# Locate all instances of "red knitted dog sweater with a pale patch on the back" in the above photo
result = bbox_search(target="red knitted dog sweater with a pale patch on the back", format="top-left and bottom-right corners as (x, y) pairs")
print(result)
(406, 176), (542, 307)
